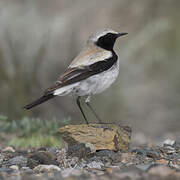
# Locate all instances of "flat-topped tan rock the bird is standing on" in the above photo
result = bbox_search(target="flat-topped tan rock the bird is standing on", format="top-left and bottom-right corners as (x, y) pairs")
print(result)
(59, 124), (131, 152)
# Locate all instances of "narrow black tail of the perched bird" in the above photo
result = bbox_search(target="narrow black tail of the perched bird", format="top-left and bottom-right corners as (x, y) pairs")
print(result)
(23, 94), (55, 109)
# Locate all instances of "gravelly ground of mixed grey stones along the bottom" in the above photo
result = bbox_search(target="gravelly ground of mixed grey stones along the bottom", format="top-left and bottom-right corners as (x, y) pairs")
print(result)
(0, 140), (180, 180)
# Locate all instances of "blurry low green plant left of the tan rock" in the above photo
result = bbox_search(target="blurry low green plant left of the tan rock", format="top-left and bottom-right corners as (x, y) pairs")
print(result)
(0, 115), (69, 148)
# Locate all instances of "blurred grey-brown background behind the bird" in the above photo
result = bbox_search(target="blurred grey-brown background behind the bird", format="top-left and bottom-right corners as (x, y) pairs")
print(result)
(0, 0), (180, 146)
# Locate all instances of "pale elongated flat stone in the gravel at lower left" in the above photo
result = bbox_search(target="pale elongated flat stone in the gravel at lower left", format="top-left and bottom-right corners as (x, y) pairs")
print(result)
(33, 164), (61, 173)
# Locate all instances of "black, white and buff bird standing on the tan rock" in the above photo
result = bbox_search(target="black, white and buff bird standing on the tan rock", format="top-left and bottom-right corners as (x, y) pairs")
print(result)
(24, 29), (128, 124)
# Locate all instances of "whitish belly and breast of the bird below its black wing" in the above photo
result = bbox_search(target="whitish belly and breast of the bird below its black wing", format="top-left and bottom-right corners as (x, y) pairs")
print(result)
(72, 61), (119, 96)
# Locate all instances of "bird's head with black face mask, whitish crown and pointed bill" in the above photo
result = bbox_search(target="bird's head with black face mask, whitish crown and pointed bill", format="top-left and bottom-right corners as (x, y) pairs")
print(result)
(88, 29), (128, 50)
